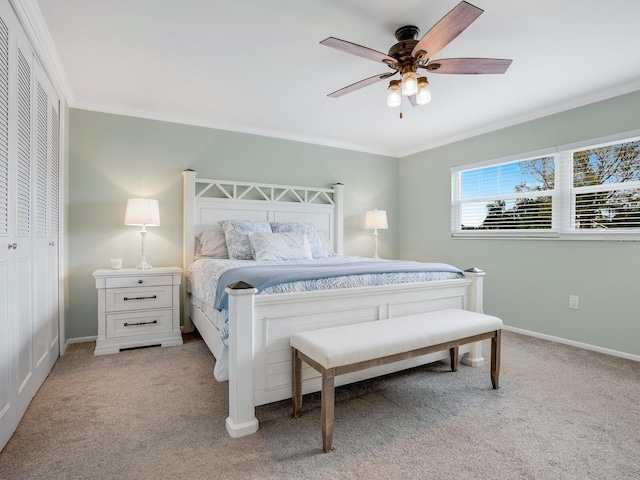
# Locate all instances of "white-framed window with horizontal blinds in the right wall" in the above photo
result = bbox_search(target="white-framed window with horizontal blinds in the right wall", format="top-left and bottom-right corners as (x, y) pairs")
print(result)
(451, 131), (640, 238)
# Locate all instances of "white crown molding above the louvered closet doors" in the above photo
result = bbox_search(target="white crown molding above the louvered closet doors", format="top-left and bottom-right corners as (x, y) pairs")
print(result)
(9, 0), (76, 105)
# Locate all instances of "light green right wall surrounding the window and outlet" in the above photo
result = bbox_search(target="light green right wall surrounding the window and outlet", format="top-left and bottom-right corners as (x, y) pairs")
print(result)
(399, 92), (640, 355)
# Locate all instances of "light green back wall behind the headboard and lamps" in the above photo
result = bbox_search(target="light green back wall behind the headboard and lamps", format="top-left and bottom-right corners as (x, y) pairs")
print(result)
(71, 109), (398, 339)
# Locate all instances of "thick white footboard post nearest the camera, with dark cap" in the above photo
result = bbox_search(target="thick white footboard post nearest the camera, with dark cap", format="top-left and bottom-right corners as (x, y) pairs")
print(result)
(226, 282), (258, 438)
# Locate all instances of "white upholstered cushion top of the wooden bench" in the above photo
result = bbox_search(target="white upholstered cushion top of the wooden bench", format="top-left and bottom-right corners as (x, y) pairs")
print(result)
(290, 309), (502, 368)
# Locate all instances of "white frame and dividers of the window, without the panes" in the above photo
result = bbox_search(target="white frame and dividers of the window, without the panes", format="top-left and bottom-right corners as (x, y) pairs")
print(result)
(451, 130), (640, 242)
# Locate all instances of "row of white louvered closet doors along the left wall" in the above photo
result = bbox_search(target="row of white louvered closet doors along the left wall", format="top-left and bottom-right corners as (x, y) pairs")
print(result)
(0, 0), (60, 449)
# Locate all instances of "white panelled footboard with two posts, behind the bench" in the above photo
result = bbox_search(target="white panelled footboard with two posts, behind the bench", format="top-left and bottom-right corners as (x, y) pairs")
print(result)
(227, 269), (484, 437)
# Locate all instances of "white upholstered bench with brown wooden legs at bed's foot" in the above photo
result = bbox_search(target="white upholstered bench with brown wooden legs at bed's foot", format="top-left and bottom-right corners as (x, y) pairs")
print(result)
(290, 309), (502, 453)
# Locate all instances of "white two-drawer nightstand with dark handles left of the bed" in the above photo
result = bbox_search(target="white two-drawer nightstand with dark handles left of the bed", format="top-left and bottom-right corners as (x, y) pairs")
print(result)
(93, 267), (182, 355)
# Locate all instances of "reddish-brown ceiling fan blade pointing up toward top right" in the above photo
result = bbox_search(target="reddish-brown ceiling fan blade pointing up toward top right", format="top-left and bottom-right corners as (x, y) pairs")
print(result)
(411, 2), (484, 60)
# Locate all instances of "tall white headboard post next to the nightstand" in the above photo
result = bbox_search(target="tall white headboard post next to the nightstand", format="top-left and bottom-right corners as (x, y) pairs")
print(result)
(180, 170), (196, 332)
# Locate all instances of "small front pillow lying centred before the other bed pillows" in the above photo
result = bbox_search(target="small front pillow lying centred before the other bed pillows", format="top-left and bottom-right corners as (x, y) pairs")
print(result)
(249, 232), (313, 260)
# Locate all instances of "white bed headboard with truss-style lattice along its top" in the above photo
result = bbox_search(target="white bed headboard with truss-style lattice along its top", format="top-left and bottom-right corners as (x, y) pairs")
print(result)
(182, 170), (344, 272)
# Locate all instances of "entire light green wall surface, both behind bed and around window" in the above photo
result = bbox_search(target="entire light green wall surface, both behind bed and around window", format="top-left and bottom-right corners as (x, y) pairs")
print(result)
(65, 92), (640, 355)
